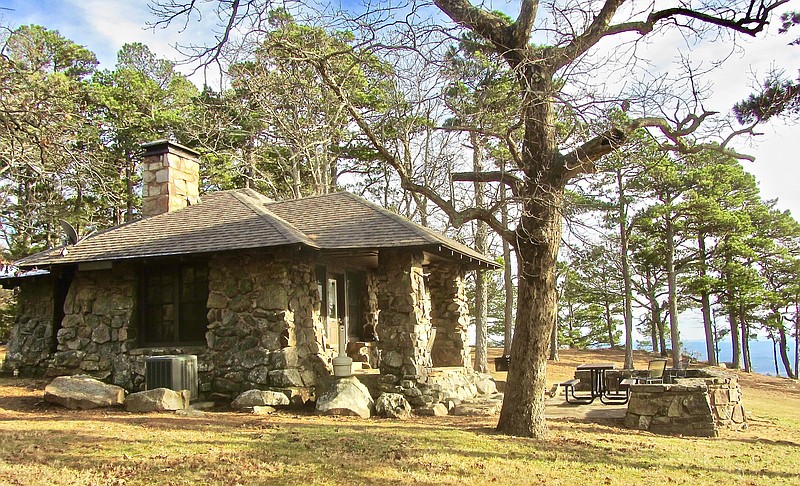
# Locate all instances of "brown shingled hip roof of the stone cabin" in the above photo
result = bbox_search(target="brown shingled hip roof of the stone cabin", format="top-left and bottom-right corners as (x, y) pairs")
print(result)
(16, 189), (497, 268)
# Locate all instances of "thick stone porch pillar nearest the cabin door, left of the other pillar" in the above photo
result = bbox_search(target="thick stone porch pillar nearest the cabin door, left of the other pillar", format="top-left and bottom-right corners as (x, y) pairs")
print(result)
(375, 250), (432, 380)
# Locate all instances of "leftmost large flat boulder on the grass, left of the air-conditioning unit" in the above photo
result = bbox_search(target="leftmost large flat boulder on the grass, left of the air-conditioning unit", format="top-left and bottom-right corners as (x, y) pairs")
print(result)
(44, 375), (125, 410)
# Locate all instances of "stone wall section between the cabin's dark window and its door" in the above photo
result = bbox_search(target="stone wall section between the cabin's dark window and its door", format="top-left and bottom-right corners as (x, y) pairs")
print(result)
(206, 249), (328, 395)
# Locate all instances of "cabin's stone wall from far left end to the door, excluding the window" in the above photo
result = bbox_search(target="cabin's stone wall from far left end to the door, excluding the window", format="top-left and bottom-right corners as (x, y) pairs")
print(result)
(6, 251), (330, 399)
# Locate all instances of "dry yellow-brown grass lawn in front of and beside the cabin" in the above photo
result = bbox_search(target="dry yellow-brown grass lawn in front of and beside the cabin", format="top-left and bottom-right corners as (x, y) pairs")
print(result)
(0, 350), (800, 485)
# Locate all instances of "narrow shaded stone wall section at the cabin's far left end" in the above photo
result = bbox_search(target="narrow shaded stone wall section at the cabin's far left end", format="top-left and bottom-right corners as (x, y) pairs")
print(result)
(3, 275), (54, 376)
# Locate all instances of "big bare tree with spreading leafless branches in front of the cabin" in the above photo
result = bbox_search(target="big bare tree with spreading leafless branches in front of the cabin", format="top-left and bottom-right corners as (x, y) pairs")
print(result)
(150, 0), (788, 437)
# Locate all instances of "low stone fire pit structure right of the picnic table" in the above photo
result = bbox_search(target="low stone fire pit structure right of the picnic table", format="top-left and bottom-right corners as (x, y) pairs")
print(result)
(625, 368), (747, 437)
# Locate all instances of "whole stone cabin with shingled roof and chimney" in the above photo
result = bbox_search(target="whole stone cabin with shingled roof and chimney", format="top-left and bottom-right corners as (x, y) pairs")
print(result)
(2, 141), (497, 397)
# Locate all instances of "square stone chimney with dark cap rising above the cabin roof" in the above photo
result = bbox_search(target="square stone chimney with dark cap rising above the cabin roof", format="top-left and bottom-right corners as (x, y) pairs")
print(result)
(142, 140), (200, 218)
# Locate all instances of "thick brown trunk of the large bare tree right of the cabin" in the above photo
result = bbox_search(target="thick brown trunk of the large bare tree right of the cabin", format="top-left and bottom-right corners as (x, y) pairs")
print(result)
(497, 63), (567, 438)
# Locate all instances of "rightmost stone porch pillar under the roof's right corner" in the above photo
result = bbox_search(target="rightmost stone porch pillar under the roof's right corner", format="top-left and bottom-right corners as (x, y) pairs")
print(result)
(428, 263), (472, 368)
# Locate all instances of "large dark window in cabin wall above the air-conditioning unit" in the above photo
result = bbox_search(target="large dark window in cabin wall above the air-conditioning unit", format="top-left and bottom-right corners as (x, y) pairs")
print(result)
(140, 263), (208, 345)
